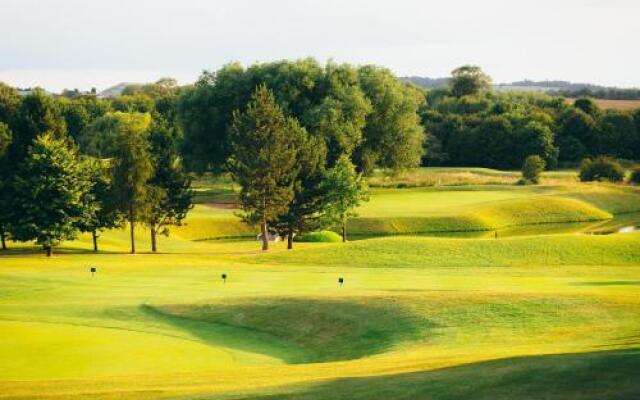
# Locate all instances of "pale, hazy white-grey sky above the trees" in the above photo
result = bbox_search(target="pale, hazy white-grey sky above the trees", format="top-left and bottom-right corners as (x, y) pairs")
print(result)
(0, 0), (640, 92)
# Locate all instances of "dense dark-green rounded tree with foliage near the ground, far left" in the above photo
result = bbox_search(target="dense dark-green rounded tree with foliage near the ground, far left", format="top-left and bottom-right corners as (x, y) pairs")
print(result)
(11, 134), (91, 256)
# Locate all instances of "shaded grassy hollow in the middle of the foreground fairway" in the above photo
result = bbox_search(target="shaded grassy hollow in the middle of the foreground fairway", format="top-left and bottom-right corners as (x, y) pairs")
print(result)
(154, 298), (432, 363)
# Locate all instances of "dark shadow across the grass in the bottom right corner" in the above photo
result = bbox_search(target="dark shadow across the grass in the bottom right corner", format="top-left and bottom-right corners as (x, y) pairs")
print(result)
(189, 348), (640, 400)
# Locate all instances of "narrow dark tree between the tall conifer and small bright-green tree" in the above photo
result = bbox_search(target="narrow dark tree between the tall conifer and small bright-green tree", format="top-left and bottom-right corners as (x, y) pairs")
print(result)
(274, 134), (328, 249)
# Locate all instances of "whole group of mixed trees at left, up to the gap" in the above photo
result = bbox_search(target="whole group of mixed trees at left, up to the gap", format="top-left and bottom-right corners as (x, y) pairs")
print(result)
(0, 80), (192, 255)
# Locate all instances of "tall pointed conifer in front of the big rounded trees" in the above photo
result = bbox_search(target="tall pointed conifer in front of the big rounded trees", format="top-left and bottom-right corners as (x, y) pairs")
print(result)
(230, 85), (304, 250)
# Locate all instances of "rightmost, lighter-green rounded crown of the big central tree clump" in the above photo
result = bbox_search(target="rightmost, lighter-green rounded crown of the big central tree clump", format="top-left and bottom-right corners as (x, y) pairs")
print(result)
(358, 66), (425, 174)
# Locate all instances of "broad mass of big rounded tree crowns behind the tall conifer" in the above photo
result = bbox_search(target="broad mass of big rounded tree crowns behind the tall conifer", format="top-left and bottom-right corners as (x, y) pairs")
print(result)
(177, 59), (424, 172)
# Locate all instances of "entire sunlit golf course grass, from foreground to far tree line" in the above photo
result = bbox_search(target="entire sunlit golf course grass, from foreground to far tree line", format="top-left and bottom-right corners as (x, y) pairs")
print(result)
(0, 168), (640, 400)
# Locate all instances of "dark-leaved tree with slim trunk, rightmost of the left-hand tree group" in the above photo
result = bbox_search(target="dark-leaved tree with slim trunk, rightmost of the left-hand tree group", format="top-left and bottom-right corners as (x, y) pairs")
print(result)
(146, 119), (193, 252)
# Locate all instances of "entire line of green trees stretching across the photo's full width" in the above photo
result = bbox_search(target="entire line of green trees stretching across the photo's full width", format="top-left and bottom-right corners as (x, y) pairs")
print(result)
(0, 59), (640, 252)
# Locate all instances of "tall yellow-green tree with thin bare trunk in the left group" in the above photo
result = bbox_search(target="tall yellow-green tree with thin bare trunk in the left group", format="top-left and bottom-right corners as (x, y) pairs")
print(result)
(110, 113), (153, 254)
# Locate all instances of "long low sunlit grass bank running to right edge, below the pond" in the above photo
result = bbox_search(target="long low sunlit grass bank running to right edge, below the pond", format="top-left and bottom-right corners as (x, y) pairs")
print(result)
(255, 234), (640, 268)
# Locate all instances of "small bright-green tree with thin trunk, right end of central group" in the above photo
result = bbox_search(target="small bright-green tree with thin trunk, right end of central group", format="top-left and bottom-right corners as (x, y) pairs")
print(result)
(324, 157), (369, 242)
